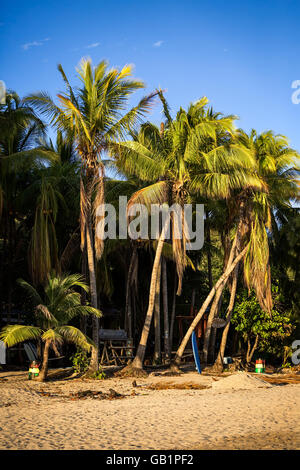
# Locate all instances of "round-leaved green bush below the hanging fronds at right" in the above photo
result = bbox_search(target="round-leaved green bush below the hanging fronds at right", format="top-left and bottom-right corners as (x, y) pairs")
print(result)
(232, 291), (293, 366)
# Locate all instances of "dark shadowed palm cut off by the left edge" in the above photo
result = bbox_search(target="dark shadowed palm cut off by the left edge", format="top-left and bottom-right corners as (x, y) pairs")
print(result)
(0, 92), (56, 320)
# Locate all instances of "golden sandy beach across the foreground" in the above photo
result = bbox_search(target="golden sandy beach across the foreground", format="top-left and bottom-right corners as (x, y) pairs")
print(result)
(0, 372), (300, 450)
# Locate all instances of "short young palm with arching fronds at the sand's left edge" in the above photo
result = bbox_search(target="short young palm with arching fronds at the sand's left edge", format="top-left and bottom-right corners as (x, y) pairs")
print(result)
(0, 274), (101, 382)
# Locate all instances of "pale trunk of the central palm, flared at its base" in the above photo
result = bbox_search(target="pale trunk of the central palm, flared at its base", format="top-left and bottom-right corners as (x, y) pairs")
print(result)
(124, 220), (167, 370)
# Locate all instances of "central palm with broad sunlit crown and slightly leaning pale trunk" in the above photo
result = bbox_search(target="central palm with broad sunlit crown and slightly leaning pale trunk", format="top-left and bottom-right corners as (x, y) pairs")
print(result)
(111, 92), (253, 375)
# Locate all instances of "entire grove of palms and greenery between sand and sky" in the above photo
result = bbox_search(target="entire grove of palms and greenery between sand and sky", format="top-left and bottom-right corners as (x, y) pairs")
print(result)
(0, 59), (300, 380)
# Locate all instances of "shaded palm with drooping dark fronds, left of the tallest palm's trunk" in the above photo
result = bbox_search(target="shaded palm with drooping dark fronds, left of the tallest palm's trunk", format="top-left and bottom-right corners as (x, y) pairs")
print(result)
(18, 137), (80, 285)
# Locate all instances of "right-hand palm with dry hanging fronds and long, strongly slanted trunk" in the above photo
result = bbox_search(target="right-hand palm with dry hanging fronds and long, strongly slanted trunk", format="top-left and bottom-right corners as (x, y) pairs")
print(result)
(175, 130), (298, 365)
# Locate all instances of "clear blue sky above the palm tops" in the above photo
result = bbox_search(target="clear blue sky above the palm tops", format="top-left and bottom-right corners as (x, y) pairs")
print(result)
(0, 0), (300, 151)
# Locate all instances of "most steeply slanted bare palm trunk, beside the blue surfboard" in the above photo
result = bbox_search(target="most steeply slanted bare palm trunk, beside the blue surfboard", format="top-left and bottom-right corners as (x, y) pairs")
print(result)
(174, 244), (249, 366)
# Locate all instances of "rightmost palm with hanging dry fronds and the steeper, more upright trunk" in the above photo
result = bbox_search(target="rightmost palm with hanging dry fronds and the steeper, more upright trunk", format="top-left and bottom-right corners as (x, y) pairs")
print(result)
(216, 129), (299, 368)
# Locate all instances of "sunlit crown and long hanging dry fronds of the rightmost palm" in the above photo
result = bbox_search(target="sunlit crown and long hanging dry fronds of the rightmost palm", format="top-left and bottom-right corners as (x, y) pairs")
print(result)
(237, 129), (299, 311)
